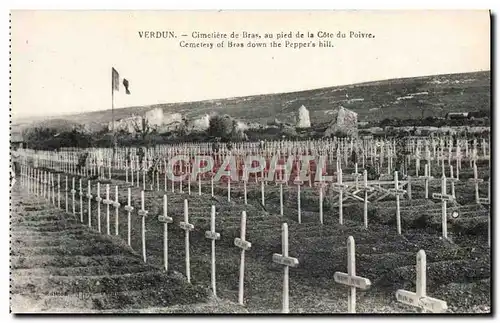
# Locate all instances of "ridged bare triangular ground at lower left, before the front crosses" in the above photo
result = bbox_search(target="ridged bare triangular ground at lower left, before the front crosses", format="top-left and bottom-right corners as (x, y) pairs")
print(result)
(10, 182), (245, 313)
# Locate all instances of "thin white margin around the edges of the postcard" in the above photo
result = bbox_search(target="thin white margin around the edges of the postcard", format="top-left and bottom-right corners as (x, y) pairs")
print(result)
(0, 0), (500, 322)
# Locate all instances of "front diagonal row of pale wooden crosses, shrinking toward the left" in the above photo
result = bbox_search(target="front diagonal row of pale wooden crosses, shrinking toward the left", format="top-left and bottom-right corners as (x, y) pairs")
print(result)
(21, 166), (458, 313)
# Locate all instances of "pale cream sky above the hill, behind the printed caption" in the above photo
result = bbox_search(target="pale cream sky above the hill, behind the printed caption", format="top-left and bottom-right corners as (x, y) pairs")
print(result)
(11, 10), (490, 118)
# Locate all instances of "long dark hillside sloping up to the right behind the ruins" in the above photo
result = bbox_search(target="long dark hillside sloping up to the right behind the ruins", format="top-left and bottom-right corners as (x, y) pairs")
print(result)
(13, 71), (491, 132)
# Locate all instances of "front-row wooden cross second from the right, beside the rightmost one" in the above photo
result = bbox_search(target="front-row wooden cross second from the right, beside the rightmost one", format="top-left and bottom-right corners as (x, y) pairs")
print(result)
(333, 236), (371, 313)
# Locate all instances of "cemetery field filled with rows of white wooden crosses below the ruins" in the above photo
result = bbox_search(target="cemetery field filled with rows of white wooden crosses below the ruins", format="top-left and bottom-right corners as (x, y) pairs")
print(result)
(10, 135), (491, 313)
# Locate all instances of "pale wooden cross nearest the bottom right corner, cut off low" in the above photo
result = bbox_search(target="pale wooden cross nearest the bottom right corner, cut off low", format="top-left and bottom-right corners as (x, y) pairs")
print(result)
(396, 250), (448, 313)
